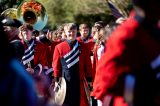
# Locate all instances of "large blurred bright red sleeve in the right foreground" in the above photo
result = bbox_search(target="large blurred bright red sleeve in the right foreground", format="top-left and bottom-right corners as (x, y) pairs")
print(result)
(91, 17), (138, 100)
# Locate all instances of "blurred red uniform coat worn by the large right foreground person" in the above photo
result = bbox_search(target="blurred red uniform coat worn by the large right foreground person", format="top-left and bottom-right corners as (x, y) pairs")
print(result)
(92, 11), (160, 106)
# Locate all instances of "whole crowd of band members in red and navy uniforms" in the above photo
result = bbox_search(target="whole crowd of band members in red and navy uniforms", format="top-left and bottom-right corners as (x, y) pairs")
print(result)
(0, 0), (160, 106)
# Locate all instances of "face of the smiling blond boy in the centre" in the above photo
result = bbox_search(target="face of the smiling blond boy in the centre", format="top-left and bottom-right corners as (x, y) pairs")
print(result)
(65, 29), (77, 41)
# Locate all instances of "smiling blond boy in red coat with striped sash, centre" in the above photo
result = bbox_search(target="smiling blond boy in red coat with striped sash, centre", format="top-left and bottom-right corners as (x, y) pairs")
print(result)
(52, 23), (92, 106)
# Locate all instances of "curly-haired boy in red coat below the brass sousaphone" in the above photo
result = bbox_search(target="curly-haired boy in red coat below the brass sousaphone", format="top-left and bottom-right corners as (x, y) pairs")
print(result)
(19, 23), (46, 73)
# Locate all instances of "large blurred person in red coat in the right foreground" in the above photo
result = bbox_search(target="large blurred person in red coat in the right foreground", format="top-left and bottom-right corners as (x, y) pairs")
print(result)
(92, 0), (160, 106)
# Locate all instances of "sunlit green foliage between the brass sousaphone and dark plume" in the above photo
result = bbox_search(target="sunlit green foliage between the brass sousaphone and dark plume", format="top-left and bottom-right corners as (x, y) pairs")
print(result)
(39, 0), (111, 27)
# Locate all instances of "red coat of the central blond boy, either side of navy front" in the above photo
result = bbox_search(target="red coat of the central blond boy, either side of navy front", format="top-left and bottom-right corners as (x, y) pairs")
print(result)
(52, 41), (92, 106)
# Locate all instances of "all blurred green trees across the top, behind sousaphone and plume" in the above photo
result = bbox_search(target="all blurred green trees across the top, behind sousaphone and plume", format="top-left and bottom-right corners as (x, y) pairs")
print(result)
(0, 0), (132, 29)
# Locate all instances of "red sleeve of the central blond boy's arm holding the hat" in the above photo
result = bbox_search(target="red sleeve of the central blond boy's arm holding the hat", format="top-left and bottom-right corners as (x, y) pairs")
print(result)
(52, 46), (61, 77)
